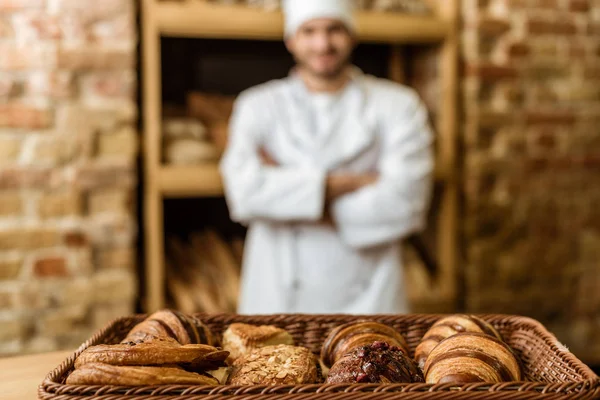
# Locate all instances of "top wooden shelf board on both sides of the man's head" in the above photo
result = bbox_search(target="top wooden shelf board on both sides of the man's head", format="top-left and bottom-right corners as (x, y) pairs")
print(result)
(155, 0), (452, 43)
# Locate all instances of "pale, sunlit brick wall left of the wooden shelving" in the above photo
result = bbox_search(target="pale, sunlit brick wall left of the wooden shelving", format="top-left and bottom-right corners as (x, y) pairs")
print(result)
(0, 0), (138, 355)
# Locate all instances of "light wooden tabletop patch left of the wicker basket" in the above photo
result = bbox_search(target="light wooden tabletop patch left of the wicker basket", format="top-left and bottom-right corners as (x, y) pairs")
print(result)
(0, 351), (74, 400)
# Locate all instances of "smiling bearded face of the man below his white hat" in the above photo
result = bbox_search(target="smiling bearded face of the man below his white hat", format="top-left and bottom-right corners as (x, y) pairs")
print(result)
(286, 18), (355, 79)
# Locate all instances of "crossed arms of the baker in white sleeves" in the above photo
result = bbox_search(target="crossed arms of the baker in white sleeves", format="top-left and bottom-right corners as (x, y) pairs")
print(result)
(221, 91), (433, 248)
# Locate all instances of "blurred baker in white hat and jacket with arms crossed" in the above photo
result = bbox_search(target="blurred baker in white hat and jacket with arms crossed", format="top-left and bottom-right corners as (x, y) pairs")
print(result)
(221, 0), (433, 314)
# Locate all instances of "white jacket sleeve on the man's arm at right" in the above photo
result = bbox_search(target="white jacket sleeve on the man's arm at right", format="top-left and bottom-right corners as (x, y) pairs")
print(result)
(332, 94), (434, 248)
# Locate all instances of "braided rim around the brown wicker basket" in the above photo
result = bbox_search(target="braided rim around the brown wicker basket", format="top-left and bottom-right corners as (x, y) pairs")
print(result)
(38, 313), (600, 399)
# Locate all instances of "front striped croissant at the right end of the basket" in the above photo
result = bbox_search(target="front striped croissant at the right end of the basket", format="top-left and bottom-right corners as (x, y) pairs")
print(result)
(425, 332), (521, 383)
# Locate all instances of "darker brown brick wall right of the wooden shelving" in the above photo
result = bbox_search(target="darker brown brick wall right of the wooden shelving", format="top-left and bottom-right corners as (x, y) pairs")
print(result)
(462, 0), (600, 363)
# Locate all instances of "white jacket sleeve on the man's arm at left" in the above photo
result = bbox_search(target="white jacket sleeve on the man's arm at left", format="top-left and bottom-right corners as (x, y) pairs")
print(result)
(220, 94), (326, 223)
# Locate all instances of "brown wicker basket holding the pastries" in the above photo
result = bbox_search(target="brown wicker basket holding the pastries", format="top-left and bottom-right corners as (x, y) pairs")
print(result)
(38, 314), (600, 400)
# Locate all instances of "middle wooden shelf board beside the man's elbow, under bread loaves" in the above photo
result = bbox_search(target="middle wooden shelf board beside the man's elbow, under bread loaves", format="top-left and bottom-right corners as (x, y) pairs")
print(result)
(158, 163), (223, 198)
